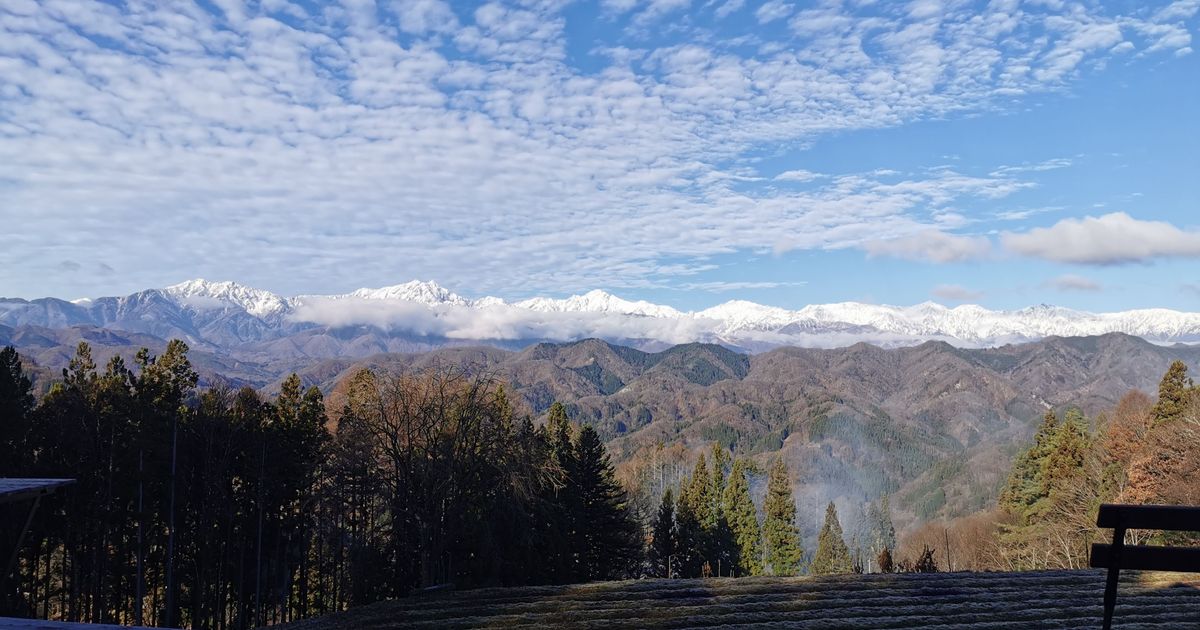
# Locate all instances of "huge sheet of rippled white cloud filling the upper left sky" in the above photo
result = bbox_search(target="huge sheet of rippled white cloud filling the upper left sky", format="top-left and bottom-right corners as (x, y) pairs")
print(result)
(0, 0), (1194, 294)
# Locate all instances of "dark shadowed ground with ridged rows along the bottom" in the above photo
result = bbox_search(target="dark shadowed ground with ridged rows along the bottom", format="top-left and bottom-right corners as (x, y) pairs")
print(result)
(292, 571), (1200, 630)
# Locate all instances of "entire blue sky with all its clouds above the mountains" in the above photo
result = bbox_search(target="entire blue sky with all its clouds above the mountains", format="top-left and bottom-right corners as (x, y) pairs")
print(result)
(0, 0), (1200, 311)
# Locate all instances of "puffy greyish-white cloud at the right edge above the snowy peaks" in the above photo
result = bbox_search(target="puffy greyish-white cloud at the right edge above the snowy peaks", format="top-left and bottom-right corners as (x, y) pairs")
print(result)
(1001, 212), (1200, 265)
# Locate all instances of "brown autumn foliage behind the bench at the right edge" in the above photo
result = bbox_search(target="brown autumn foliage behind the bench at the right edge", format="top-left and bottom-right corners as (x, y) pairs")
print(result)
(896, 357), (1200, 570)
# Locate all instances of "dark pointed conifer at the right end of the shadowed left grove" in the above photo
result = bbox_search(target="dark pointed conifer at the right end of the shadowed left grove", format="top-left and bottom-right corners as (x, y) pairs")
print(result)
(574, 425), (642, 580)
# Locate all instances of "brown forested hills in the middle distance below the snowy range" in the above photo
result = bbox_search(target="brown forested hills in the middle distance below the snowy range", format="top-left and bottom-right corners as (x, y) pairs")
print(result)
(301, 334), (1200, 540)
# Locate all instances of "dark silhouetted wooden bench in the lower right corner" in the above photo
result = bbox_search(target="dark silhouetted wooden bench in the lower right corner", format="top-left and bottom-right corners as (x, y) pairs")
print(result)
(1091, 504), (1200, 630)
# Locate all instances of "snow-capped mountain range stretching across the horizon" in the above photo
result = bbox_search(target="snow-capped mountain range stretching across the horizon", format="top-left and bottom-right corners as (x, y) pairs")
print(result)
(7, 280), (1200, 356)
